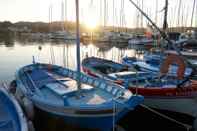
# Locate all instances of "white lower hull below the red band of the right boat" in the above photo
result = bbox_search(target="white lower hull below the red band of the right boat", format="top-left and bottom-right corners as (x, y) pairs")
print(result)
(144, 97), (197, 118)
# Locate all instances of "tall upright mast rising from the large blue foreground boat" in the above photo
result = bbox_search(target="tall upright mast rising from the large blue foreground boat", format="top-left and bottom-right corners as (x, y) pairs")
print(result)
(75, 0), (81, 93)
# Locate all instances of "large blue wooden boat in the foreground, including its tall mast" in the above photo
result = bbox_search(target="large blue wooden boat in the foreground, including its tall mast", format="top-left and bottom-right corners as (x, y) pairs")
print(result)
(13, 0), (143, 131)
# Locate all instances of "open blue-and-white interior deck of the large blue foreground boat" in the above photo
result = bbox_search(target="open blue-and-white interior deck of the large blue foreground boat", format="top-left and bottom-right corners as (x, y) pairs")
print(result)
(19, 65), (129, 106)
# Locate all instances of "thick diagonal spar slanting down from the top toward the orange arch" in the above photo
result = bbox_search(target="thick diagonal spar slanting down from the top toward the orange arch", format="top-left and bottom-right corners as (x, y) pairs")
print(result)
(129, 0), (197, 77)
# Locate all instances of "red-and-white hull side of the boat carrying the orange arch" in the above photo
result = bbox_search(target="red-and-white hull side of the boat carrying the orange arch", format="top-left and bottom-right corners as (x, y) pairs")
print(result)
(82, 66), (197, 117)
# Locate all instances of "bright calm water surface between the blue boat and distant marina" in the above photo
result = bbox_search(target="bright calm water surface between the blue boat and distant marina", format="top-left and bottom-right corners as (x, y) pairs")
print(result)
(0, 39), (144, 81)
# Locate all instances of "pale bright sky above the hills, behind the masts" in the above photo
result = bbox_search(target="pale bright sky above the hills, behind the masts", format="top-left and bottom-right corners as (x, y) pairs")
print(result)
(0, 0), (197, 27)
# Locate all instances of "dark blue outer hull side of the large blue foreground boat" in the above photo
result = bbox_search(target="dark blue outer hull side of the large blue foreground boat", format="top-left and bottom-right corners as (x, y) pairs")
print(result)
(31, 95), (130, 131)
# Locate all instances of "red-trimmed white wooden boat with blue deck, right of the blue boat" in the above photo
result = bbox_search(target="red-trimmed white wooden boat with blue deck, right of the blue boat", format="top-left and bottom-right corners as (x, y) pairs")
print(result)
(82, 57), (197, 126)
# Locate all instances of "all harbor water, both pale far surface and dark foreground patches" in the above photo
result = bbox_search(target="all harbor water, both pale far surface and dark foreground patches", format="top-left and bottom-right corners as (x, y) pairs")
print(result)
(0, 39), (192, 131)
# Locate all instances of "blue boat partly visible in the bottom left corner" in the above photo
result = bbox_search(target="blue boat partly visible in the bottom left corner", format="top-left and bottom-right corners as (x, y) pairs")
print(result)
(0, 86), (28, 131)
